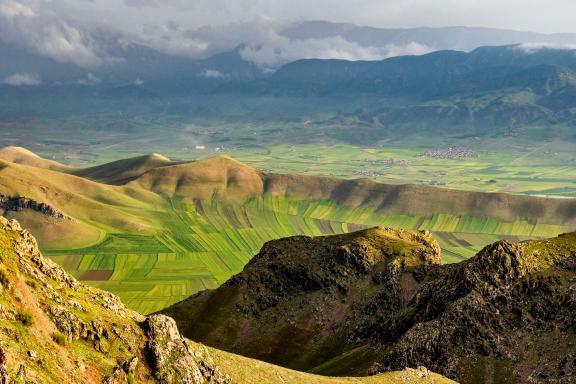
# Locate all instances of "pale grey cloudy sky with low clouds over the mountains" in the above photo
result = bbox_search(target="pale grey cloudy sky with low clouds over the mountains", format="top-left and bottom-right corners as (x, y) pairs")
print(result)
(0, 0), (576, 68)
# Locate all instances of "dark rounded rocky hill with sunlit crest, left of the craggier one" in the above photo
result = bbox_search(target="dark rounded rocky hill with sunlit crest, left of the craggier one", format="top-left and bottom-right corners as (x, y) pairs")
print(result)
(167, 228), (441, 373)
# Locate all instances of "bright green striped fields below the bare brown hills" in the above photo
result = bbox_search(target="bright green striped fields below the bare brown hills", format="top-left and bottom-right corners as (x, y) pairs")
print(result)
(46, 196), (566, 313)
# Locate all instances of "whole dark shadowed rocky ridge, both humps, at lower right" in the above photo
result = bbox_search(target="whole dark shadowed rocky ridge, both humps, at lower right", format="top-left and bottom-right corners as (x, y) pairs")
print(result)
(167, 226), (576, 383)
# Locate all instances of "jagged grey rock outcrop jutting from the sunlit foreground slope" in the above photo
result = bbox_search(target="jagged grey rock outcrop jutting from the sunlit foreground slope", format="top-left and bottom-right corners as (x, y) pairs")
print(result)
(146, 315), (230, 384)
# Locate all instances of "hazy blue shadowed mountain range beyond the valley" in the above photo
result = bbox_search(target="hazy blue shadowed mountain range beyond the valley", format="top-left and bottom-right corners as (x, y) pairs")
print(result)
(0, 41), (576, 140)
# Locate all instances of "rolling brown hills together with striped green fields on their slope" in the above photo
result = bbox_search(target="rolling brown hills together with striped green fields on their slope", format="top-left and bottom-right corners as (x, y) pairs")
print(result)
(0, 151), (576, 313)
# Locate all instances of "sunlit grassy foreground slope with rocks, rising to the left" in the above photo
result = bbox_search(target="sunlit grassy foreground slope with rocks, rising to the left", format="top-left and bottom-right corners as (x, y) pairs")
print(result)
(0, 216), (452, 384)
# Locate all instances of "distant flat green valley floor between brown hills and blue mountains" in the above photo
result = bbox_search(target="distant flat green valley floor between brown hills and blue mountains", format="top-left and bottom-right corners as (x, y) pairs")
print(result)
(6, 111), (576, 197)
